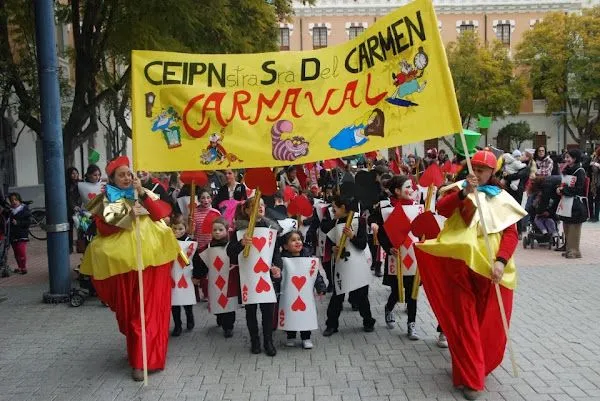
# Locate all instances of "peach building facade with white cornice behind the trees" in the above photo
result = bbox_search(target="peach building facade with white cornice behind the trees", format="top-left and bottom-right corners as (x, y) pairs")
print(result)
(279, 0), (600, 155)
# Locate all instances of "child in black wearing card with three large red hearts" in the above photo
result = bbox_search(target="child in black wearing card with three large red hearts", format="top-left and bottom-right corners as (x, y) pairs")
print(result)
(227, 198), (282, 356)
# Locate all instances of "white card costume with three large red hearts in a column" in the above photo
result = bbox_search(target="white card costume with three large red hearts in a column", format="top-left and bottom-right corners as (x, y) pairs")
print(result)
(236, 227), (277, 305)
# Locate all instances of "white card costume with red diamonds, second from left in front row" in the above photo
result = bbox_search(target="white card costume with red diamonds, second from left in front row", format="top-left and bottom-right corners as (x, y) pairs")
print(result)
(200, 246), (238, 315)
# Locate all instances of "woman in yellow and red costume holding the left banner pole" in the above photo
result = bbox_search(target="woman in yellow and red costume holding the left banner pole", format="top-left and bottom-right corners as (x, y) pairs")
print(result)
(81, 156), (180, 381)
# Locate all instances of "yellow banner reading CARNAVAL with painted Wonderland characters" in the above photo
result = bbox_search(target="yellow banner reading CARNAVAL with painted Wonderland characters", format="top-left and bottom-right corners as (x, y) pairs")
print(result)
(132, 0), (462, 171)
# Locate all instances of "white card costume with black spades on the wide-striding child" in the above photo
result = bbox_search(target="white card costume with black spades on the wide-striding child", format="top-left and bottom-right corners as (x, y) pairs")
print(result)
(327, 217), (371, 294)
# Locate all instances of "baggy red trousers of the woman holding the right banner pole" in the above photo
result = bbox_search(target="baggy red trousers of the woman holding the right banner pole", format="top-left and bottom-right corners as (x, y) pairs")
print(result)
(415, 248), (513, 390)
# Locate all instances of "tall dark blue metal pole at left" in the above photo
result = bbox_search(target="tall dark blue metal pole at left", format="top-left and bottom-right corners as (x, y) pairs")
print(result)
(34, 0), (71, 303)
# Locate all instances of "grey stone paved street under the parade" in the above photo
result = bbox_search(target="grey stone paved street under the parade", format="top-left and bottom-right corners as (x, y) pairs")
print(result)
(0, 223), (600, 401)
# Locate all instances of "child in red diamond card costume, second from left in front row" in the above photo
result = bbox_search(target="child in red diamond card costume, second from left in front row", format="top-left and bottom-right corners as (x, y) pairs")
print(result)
(194, 217), (240, 338)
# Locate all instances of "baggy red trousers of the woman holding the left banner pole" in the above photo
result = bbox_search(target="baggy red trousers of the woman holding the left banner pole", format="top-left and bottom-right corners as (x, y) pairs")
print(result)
(93, 263), (171, 370)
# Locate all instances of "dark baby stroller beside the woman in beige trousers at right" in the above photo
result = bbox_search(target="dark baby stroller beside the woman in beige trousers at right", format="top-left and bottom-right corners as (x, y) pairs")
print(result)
(523, 176), (565, 249)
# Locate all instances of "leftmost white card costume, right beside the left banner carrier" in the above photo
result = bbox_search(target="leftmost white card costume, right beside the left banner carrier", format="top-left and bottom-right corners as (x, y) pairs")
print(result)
(171, 241), (198, 306)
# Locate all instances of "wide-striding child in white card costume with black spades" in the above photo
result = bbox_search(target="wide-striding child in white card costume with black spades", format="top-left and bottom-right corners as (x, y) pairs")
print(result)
(323, 196), (375, 337)
